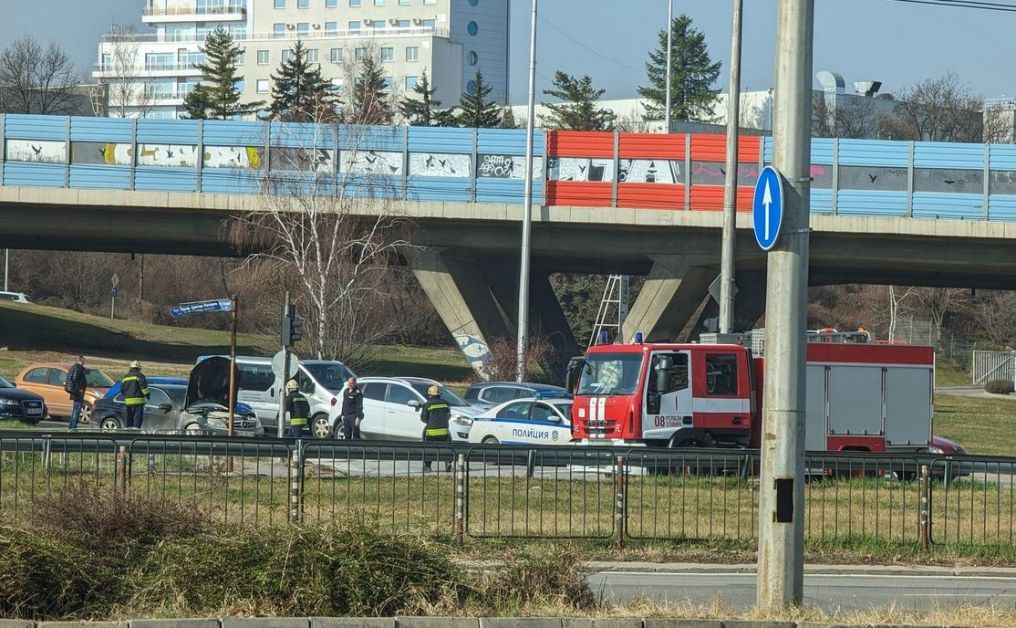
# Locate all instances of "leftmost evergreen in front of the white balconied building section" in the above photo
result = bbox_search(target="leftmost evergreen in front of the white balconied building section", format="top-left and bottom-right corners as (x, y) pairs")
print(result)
(184, 26), (264, 120)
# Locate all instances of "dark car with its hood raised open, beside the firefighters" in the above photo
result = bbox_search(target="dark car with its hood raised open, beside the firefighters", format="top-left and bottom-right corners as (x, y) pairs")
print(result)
(93, 358), (264, 436)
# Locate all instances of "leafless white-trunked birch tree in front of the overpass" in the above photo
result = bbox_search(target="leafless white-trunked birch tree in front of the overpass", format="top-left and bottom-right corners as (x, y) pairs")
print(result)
(231, 118), (407, 364)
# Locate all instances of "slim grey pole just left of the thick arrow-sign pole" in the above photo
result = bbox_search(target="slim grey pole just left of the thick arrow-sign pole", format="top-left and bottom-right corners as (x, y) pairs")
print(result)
(719, 0), (744, 333)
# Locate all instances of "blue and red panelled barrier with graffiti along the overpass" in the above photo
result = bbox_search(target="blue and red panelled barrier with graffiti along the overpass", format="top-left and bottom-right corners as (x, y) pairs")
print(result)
(0, 114), (1016, 221)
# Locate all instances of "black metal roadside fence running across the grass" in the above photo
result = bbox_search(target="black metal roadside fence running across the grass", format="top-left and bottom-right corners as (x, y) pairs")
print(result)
(0, 432), (1016, 547)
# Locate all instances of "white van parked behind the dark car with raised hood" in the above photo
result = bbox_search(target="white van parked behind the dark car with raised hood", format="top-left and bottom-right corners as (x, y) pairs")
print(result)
(197, 356), (356, 438)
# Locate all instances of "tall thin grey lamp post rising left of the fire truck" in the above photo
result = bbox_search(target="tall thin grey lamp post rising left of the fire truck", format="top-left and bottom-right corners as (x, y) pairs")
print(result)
(515, 0), (537, 382)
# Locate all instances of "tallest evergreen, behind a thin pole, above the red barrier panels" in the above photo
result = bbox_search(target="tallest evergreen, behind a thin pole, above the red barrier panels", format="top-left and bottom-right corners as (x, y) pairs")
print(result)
(638, 14), (720, 120)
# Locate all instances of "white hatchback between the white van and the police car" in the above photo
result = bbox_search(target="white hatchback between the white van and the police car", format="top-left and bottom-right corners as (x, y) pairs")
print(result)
(327, 377), (481, 441)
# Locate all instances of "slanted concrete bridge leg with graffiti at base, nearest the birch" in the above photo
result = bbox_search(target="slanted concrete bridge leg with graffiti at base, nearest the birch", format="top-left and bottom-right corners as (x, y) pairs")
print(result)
(405, 247), (511, 376)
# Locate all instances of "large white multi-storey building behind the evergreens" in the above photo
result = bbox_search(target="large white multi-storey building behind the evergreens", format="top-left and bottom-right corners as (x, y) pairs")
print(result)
(92, 0), (509, 118)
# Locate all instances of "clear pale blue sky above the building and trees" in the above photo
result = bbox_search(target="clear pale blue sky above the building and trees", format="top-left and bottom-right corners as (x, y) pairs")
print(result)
(0, 0), (1016, 103)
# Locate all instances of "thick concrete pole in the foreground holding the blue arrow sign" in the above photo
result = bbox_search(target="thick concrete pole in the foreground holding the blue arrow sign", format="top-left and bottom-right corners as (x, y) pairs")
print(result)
(756, 0), (815, 609)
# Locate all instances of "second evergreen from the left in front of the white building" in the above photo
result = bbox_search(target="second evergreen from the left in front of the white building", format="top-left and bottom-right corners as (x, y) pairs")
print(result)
(268, 40), (338, 122)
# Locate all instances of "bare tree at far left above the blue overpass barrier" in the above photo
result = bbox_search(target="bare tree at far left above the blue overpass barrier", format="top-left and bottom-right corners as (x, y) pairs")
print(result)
(0, 36), (78, 114)
